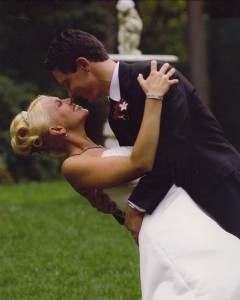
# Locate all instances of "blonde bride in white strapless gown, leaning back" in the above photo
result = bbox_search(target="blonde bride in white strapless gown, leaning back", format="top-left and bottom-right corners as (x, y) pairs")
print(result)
(10, 61), (240, 300)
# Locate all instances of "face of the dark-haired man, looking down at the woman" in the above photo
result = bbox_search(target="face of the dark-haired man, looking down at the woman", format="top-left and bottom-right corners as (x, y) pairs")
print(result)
(52, 67), (102, 102)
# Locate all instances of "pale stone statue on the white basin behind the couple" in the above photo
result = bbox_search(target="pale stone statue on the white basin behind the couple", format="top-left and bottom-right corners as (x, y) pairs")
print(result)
(116, 0), (143, 55)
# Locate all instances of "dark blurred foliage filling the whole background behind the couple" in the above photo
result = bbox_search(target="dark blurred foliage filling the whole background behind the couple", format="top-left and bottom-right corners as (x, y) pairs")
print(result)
(0, 0), (240, 182)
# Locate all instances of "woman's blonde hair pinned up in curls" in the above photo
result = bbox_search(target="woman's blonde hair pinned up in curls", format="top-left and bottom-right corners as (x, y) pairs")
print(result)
(10, 95), (65, 156)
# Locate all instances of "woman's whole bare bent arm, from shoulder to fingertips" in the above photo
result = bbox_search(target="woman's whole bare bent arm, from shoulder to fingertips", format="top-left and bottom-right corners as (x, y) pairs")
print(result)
(62, 61), (178, 189)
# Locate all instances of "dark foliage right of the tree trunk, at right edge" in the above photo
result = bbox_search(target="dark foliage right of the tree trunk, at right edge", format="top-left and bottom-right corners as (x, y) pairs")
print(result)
(206, 0), (240, 150)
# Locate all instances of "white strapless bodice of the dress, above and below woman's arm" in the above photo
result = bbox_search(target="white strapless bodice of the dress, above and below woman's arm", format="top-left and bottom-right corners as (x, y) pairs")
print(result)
(102, 146), (139, 212)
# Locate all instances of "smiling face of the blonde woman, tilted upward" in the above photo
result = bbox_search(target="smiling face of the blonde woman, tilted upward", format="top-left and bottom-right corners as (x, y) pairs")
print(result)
(40, 97), (89, 129)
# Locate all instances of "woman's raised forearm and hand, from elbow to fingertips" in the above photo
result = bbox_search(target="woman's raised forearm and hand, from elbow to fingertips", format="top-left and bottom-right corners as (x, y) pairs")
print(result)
(130, 60), (178, 172)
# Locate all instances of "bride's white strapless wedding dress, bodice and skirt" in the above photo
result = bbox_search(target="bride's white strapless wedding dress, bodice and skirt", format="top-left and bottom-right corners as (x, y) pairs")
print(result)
(103, 147), (240, 300)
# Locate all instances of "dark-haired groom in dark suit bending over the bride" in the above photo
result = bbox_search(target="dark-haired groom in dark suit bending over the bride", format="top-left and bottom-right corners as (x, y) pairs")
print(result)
(45, 29), (240, 240)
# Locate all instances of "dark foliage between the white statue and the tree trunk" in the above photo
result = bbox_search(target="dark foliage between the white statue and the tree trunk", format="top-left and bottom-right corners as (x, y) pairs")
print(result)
(137, 0), (188, 69)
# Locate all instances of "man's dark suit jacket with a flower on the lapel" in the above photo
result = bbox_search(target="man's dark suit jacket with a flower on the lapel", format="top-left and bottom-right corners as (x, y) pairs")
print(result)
(109, 62), (240, 236)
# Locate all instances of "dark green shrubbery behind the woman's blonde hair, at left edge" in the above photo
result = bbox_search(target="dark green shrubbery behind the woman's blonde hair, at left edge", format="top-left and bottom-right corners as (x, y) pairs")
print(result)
(0, 76), (60, 182)
